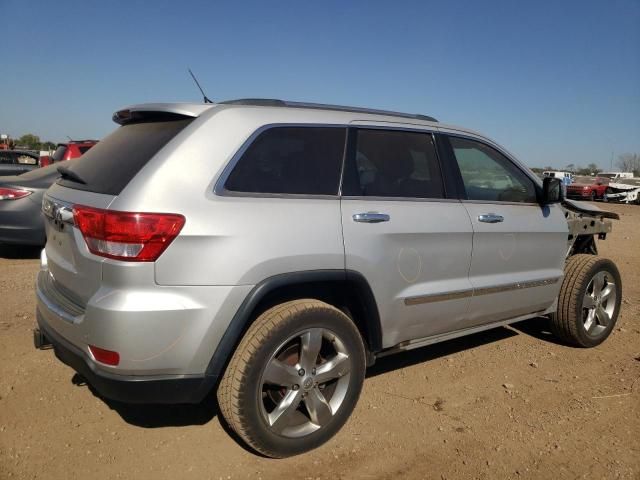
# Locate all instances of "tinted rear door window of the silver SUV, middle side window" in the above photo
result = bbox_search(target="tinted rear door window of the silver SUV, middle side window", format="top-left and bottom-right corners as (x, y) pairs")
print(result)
(342, 129), (444, 198)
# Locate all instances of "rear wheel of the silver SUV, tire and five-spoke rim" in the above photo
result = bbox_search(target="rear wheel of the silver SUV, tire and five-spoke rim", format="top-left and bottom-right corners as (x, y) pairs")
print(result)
(218, 299), (366, 458)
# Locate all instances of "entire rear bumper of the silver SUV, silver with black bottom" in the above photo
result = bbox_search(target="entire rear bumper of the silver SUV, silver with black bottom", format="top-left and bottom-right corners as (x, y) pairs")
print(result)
(36, 252), (251, 403)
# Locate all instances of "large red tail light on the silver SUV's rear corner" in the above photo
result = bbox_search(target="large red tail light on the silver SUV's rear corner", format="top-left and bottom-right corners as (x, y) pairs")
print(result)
(73, 205), (185, 262)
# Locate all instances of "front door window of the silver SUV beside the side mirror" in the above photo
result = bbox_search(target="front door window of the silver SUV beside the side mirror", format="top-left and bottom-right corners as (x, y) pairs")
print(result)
(450, 137), (536, 203)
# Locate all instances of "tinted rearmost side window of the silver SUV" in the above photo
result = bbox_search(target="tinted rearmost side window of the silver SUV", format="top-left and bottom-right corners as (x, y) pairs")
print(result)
(225, 127), (346, 195)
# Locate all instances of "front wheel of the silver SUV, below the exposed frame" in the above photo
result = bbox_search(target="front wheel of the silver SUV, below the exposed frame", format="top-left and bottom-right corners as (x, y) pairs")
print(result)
(551, 254), (622, 347)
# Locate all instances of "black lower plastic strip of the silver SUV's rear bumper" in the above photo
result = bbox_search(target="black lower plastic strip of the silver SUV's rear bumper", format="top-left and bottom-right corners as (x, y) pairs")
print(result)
(37, 311), (217, 404)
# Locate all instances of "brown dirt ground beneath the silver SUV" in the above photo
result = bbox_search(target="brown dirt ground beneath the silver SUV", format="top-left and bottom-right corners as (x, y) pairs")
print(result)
(0, 205), (640, 480)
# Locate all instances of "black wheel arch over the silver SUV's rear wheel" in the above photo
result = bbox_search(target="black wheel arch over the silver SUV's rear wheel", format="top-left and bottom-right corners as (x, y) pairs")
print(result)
(206, 270), (382, 379)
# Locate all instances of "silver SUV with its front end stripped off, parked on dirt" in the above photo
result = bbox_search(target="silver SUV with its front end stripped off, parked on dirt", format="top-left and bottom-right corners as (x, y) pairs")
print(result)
(34, 100), (621, 457)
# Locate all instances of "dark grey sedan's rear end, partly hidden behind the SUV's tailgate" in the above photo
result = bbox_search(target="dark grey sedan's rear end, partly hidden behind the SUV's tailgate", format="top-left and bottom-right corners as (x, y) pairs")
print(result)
(0, 165), (60, 245)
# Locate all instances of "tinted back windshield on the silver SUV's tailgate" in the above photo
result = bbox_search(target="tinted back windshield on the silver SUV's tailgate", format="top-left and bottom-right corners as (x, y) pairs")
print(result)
(58, 118), (193, 195)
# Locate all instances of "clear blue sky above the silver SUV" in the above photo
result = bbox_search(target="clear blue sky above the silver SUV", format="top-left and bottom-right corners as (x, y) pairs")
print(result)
(0, 0), (640, 169)
